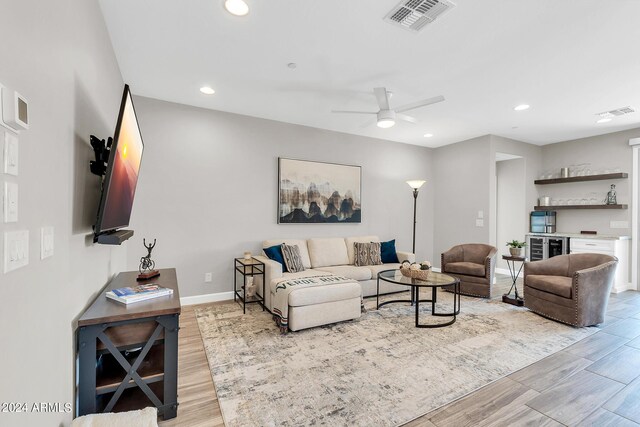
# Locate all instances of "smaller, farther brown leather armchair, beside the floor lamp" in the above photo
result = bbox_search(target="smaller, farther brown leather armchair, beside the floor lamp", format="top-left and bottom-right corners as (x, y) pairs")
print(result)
(440, 243), (498, 298)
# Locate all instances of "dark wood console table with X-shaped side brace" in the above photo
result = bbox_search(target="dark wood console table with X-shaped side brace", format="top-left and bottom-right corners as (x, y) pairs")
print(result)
(76, 268), (180, 420)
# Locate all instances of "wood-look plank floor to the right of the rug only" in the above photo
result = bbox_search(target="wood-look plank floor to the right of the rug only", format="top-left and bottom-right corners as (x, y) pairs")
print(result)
(405, 291), (640, 427)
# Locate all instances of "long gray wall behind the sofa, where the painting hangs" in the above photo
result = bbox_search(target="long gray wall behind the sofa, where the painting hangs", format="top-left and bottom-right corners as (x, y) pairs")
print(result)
(128, 97), (434, 296)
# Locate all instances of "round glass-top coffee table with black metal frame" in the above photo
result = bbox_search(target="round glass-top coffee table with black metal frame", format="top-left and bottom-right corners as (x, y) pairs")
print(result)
(376, 269), (460, 328)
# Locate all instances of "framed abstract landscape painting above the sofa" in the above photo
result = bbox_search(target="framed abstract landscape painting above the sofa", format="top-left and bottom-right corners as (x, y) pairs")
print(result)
(278, 158), (362, 224)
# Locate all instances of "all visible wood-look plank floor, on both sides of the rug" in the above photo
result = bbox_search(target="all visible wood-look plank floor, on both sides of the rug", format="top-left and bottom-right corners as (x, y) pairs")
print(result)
(160, 286), (640, 427)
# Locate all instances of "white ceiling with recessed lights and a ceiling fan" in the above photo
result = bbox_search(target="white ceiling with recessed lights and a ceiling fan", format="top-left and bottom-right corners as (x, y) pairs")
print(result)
(100, 0), (640, 147)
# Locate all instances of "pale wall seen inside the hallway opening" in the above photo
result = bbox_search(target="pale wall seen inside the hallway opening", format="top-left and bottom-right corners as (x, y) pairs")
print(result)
(495, 158), (527, 268)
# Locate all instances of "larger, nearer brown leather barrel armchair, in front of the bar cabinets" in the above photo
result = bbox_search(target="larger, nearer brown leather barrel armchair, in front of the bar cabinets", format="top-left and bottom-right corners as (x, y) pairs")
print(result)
(524, 254), (618, 326)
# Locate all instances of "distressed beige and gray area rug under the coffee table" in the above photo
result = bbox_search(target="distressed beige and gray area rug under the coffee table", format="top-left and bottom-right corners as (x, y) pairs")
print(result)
(196, 292), (596, 426)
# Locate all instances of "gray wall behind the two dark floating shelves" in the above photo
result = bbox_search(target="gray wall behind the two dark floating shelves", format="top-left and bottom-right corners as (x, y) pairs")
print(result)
(537, 129), (640, 235)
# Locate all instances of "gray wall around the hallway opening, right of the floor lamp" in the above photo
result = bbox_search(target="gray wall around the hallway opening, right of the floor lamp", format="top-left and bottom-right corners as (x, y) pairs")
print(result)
(433, 135), (541, 265)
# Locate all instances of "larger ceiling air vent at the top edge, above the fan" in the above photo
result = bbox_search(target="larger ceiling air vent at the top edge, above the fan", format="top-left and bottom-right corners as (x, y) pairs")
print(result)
(384, 0), (455, 31)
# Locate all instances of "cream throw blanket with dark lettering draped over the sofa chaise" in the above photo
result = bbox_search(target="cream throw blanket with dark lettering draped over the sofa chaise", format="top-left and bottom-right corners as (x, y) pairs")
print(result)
(271, 276), (355, 333)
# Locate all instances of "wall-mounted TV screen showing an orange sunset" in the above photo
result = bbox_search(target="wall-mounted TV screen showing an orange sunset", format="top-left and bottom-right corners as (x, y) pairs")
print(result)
(96, 86), (144, 233)
